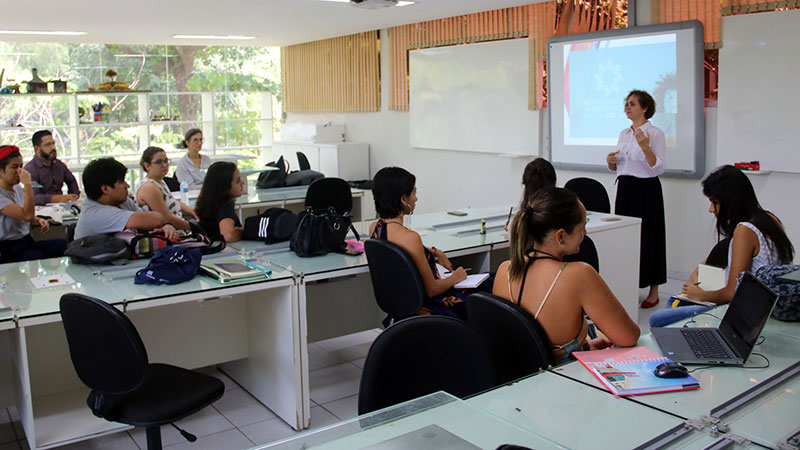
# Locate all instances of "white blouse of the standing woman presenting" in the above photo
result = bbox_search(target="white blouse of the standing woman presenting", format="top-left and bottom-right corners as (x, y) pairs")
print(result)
(615, 121), (667, 178)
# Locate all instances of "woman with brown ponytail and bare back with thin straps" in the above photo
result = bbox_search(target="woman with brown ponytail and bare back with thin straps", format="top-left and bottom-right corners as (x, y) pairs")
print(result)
(492, 188), (639, 364)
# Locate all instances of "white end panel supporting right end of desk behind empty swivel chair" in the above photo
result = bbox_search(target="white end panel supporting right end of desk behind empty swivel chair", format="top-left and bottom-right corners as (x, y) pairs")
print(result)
(220, 282), (311, 430)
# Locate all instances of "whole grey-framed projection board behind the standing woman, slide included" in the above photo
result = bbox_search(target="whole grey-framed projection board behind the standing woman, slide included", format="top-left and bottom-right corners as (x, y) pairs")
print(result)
(547, 21), (705, 178)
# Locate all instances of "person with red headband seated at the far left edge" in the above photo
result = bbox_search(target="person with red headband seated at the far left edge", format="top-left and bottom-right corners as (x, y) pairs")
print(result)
(0, 145), (67, 263)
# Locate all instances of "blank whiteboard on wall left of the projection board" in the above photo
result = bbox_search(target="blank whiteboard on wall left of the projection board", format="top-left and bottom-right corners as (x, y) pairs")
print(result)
(409, 39), (539, 155)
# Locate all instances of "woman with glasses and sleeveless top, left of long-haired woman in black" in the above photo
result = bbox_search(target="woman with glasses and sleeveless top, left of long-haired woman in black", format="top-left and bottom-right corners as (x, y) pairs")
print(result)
(136, 147), (197, 230)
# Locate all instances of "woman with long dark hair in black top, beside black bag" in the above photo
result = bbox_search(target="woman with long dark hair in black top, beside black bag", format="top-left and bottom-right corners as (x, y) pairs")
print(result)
(194, 161), (244, 242)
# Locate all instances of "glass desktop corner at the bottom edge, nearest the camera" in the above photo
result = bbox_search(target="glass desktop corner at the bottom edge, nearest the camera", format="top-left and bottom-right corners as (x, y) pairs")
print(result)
(257, 392), (564, 450)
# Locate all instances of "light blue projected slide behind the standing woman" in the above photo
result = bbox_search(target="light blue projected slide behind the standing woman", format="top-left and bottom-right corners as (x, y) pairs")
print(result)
(563, 34), (678, 146)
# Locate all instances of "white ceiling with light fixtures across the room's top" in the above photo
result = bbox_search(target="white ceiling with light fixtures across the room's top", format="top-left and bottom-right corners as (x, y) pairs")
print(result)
(0, 0), (542, 46)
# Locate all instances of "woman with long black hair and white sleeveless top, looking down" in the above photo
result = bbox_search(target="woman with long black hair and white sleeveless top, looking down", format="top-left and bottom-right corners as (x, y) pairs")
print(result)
(650, 165), (794, 327)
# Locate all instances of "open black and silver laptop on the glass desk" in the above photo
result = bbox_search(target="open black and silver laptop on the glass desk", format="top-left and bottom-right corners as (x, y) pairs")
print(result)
(651, 272), (778, 365)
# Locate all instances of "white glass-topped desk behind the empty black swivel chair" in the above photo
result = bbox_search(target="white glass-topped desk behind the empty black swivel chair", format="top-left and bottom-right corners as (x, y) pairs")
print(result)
(0, 251), (309, 448)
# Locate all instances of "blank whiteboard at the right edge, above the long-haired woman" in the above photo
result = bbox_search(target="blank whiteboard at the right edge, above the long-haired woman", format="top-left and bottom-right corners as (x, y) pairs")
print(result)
(717, 10), (800, 172)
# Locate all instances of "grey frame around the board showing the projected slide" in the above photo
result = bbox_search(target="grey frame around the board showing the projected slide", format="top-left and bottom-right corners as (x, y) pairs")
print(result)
(546, 20), (706, 179)
